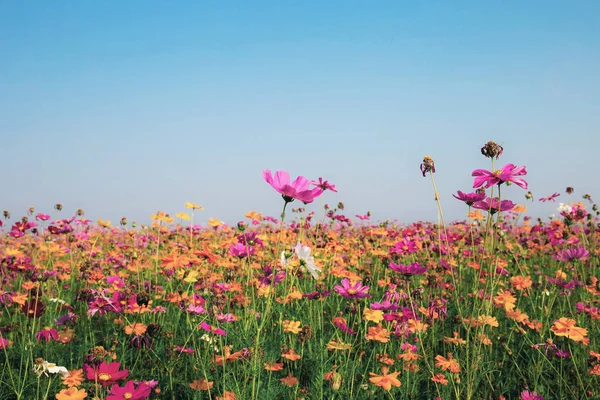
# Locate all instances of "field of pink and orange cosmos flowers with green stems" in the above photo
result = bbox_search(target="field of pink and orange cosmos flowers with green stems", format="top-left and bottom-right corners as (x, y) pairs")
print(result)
(0, 142), (600, 400)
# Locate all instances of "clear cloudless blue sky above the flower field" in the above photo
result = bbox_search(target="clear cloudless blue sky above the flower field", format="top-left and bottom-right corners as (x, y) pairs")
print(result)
(0, 0), (600, 224)
